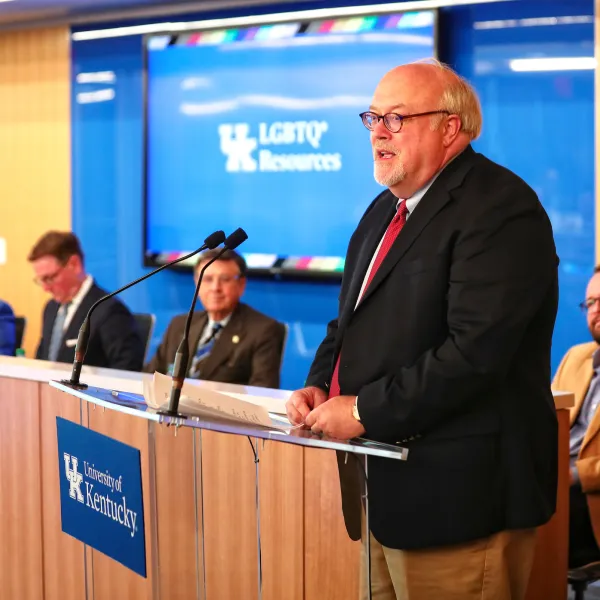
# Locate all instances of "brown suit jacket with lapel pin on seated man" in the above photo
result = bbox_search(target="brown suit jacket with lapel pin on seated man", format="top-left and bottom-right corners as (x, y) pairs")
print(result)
(144, 303), (285, 388)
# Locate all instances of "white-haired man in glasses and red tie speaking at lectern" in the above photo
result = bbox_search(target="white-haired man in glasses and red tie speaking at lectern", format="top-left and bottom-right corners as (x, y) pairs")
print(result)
(287, 63), (558, 600)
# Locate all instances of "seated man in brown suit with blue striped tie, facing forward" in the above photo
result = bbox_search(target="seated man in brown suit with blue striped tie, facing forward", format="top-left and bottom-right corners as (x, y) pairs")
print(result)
(144, 250), (285, 388)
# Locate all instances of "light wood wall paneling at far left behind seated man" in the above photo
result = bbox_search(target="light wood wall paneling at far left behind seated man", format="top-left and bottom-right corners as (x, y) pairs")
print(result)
(0, 27), (71, 356)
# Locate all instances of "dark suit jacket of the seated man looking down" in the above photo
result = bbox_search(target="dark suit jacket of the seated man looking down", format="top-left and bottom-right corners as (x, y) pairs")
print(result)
(36, 284), (144, 371)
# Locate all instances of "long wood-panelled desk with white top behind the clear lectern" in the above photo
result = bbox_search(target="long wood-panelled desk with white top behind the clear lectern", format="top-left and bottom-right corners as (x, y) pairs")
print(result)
(0, 357), (573, 600)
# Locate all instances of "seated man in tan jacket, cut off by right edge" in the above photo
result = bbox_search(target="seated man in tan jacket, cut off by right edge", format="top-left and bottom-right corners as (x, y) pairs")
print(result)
(552, 266), (600, 568)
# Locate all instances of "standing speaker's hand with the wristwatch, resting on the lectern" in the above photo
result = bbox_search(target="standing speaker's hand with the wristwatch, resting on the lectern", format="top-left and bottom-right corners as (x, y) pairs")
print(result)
(304, 396), (365, 440)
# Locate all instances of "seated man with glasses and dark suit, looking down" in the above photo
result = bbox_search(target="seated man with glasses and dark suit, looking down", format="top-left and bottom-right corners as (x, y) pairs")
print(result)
(28, 231), (144, 371)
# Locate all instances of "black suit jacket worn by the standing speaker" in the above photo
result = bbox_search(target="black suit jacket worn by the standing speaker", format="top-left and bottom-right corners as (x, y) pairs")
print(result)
(307, 147), (558, 549)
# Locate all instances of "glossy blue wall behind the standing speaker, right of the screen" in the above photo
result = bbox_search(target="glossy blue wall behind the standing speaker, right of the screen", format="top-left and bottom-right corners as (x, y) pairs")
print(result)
(440, 0), (595, 371)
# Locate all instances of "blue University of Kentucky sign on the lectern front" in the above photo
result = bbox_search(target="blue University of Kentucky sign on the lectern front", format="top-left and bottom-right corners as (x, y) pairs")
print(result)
(56, 417), (146, 577)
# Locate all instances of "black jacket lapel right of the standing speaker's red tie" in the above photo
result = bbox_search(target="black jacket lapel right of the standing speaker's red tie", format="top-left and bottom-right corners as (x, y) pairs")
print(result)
(357, 146), (475, 308)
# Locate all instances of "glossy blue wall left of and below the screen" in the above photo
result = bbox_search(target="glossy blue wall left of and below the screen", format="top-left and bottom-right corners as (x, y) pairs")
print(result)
(72, 31), (339, 389)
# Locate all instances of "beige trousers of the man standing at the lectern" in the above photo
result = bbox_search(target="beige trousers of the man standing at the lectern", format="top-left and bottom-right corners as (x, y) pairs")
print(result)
(360, 529), (535, 600)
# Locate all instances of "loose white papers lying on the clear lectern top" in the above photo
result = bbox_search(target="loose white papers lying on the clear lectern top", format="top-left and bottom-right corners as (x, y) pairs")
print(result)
(144, 373), (291, 429)
